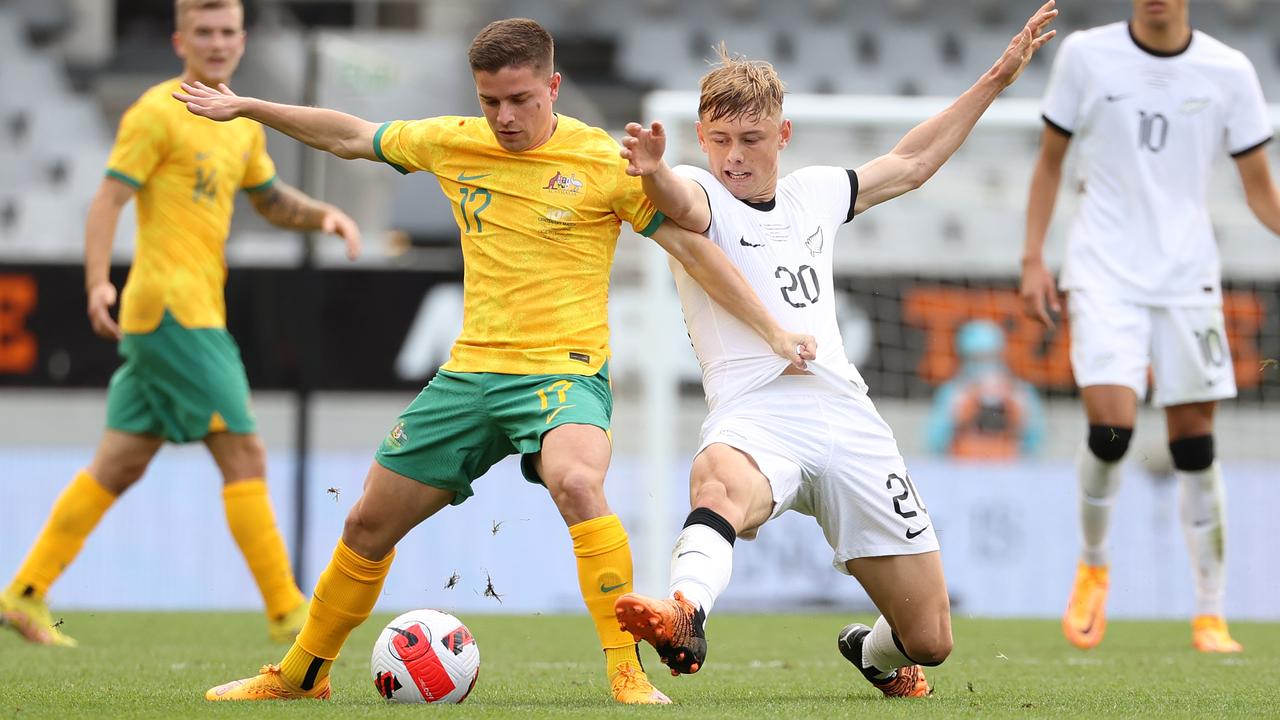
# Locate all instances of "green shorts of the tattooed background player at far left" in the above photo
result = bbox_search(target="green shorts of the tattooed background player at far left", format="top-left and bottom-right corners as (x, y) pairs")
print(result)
(106, 310), (257, 442)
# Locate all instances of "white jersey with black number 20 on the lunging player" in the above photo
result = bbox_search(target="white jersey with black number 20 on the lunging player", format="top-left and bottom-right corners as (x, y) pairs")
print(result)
(671, 165), (867, 410)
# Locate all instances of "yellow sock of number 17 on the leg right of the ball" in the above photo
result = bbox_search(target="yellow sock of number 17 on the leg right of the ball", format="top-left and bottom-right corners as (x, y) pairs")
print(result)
(568, 515), (636, 661)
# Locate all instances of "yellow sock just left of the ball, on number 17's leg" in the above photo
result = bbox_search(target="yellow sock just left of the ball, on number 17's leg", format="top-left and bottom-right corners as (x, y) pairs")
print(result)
(280, 539), (396, 691)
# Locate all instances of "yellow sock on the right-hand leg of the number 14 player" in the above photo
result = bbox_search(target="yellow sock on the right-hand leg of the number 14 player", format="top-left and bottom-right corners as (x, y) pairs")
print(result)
(223, 478), (306, 620)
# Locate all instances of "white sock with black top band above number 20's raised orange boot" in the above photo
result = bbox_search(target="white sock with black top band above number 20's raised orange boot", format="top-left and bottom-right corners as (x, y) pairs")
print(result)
(669, 507), (736, 615)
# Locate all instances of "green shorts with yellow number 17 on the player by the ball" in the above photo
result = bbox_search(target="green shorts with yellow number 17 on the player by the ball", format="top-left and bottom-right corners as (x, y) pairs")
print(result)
(374, 365), (613, 505)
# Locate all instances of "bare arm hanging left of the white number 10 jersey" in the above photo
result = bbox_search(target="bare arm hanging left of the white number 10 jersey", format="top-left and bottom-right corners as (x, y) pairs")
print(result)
(1019, 127), (1071, 328)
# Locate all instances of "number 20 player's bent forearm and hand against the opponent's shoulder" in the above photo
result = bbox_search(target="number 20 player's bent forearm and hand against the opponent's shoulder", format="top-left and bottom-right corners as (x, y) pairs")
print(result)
(620, 122), (712, 232)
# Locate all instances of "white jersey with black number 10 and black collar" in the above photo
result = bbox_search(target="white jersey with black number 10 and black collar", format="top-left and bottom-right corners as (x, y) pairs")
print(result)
(1043, 22), (1271, 305)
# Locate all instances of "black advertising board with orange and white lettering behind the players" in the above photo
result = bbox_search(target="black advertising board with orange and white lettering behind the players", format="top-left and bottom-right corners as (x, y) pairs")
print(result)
(0, 264), (1280, 402)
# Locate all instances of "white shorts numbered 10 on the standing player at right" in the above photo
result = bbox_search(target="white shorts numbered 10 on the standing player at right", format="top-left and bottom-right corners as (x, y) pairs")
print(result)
(1068, 290), (1235, 407)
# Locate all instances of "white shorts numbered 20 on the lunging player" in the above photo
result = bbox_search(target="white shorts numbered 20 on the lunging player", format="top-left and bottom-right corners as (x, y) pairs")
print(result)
(698, 375), (938, 575)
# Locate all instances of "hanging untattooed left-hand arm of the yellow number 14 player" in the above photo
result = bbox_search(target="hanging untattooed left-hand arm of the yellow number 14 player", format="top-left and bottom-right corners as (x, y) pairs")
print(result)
(84, 177), (133, 340)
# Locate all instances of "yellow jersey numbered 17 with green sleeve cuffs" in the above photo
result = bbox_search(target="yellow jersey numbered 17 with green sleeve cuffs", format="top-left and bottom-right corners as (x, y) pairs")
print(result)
(374, 115), (662, 375)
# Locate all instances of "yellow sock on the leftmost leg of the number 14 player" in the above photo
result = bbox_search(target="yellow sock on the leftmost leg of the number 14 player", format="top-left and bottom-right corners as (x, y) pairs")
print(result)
(9, 470), (115, 598)
